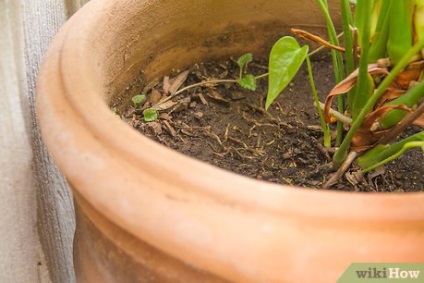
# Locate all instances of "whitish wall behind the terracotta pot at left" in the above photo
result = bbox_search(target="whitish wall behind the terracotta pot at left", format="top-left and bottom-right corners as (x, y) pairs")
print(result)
(0, 0), (87, 283)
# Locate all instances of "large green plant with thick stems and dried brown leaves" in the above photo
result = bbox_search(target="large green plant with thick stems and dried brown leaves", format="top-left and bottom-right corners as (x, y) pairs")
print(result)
(266, 0), (424, 186)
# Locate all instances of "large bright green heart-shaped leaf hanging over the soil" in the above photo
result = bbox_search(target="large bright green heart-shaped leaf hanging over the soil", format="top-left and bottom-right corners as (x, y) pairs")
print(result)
(265, 36), (309, 109)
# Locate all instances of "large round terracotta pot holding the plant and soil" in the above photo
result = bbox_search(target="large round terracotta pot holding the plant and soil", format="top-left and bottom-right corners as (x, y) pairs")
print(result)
(37, 0), (424, 282)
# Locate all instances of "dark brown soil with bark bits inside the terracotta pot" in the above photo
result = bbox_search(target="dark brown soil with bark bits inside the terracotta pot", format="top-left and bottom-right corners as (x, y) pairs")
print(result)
(113, 58), (424, 192)
